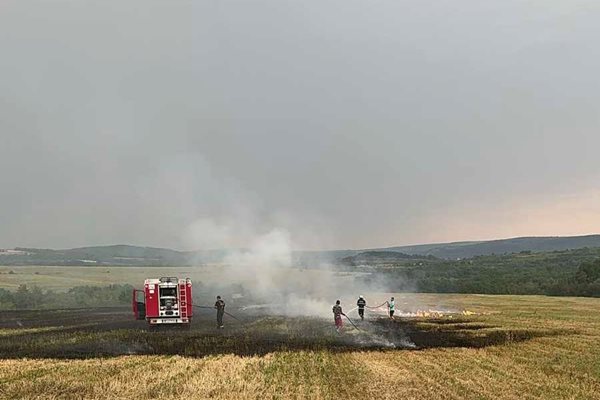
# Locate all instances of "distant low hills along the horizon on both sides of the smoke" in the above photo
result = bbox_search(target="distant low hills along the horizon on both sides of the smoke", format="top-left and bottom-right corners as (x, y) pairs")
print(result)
(0, 235), (600, 266)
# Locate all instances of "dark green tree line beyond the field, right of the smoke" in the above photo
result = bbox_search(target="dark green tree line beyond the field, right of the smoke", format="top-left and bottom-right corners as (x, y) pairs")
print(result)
(370, 251), (600, 297)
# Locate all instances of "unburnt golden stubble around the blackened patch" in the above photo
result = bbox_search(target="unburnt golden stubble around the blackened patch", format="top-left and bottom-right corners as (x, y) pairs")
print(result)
(0, 295), (600, 399)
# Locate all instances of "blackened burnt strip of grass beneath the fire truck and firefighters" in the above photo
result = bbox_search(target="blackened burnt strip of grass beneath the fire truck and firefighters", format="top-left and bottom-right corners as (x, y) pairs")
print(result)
(0, 307), (575, 359)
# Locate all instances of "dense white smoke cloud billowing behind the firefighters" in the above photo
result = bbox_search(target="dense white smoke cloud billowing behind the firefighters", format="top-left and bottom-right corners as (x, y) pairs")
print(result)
(185, 221), (396, 318)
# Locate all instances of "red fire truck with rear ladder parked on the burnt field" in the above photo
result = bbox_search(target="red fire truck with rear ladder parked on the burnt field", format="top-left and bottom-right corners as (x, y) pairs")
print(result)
(132, 277), (193, 327)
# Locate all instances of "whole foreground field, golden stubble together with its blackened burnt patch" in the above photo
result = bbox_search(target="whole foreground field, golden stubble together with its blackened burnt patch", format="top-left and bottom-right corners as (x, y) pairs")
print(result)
(0, 294), (600, 399)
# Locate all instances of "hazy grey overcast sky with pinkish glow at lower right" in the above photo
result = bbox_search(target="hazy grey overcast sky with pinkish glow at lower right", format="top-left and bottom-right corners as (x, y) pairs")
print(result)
(0, 0), (600, 249)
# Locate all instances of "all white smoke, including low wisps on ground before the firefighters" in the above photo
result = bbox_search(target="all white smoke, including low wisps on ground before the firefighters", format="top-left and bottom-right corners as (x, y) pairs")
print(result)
(188, 225), (454, 348)
